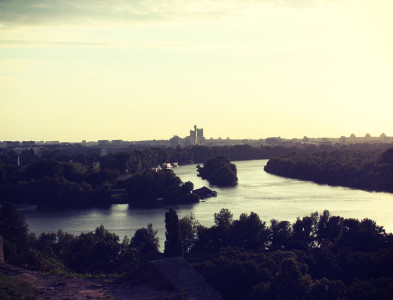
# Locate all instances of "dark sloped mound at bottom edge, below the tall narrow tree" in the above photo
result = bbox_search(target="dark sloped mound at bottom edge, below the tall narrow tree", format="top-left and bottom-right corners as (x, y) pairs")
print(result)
(129, 257), (223, 300)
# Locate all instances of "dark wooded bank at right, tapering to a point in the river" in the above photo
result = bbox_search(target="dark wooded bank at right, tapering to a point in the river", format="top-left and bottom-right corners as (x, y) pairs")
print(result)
(265, 147), (393, 193)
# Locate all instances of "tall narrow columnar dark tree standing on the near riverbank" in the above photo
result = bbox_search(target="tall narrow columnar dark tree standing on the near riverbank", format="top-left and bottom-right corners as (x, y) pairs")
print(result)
(164, 208), (182, 257)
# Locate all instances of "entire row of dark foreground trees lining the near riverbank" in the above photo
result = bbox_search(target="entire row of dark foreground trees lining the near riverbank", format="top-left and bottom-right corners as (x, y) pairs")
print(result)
(0, 204), (393, 300)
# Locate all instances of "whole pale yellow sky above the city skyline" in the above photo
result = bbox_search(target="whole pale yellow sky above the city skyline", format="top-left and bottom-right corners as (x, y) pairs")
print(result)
(0, 0), (393, 142)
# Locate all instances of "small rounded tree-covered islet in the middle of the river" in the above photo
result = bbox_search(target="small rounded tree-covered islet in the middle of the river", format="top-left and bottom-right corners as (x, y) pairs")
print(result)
(197, 156), (238, 187)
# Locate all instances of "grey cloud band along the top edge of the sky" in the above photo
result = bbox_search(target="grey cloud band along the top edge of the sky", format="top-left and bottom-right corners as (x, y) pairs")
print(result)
(0, 0), (338, 28)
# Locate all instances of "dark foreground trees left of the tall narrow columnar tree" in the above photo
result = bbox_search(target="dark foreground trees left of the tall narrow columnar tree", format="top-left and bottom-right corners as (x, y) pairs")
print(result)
(0, 202), (156, 274)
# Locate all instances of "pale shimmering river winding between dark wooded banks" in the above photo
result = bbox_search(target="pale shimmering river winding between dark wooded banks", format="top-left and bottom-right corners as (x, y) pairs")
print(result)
(23, 160), (393, 247)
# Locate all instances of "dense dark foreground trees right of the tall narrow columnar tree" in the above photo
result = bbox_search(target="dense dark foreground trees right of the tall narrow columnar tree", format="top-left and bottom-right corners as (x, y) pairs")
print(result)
(192, 209), (393, 299)
